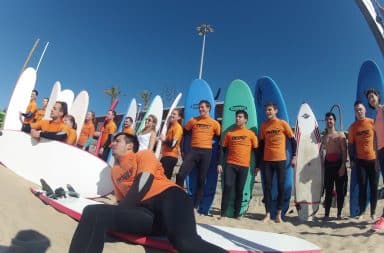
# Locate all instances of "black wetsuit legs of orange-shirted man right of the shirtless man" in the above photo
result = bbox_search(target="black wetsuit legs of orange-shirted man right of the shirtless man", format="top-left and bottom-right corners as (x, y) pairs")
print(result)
(356, 159), (379, 215)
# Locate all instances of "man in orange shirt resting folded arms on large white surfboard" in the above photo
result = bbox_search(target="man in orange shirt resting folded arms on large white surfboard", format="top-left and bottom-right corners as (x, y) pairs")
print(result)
(22, 101), (69, 142)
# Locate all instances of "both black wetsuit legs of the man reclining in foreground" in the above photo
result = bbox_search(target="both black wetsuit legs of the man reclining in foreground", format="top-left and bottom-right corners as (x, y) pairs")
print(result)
(69, 187), (226, 253)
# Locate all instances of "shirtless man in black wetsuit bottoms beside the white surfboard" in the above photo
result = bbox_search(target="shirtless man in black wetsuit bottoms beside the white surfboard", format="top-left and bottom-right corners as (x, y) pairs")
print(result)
(321, 112), (348, 219)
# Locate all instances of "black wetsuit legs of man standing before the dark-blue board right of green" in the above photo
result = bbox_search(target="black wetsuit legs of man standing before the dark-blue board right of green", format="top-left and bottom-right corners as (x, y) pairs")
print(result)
(262, 160), (286, 213)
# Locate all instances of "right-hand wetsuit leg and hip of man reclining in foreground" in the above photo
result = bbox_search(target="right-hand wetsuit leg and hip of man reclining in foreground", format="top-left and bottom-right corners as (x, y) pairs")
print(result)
(142, 187), (227, 253)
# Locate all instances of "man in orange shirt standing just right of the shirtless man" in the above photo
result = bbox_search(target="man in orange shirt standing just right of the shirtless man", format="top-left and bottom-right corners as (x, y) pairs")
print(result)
(348, 101), (379, 219)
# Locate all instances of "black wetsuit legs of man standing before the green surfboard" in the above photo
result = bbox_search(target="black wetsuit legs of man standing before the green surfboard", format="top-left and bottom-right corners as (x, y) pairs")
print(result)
(221, 164), (248, 218)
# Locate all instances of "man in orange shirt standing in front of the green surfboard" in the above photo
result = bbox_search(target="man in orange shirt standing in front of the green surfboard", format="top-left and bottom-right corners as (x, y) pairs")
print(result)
(217, 110), (259, 218)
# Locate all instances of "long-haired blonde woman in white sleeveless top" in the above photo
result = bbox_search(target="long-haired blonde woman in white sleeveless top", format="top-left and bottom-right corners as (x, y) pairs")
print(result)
(137, 114), (157, 151)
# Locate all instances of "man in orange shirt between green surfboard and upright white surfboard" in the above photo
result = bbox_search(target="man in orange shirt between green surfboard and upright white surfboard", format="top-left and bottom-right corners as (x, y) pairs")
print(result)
(259, 103), (297, 223)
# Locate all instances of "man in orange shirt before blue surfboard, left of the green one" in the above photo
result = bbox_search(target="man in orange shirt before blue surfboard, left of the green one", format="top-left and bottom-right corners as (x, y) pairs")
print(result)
(176, 100), (221, 209)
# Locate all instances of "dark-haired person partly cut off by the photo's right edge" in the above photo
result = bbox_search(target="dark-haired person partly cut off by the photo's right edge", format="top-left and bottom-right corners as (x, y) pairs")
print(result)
(365, 89), (384, 230)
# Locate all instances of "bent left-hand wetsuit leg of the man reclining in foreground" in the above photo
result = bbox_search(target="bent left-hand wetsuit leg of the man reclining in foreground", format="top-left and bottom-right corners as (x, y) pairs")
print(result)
(69, 205), (153, 253)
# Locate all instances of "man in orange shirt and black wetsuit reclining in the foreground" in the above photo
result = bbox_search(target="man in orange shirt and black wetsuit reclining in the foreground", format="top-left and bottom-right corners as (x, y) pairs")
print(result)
(69, 133), (226, 253)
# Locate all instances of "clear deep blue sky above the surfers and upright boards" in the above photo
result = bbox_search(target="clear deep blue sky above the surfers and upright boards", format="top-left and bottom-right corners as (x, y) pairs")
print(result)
(0, 0), (383, 128)
